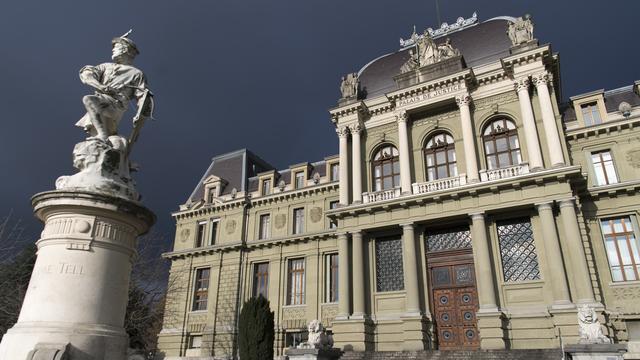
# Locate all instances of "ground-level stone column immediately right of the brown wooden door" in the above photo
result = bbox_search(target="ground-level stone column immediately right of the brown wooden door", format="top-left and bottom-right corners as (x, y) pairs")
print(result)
(471, 213), (498, 311)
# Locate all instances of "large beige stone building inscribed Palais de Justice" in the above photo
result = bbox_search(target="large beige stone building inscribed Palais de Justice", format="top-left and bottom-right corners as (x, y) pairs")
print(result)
(159, 14), (640, 359)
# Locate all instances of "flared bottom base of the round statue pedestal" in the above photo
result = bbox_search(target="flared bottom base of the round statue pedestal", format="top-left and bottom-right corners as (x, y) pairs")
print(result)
(0, 322), (129, 360)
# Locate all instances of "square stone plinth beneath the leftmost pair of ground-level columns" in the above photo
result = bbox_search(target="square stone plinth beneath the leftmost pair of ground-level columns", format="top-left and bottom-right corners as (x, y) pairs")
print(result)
(332, 316), (375, 351)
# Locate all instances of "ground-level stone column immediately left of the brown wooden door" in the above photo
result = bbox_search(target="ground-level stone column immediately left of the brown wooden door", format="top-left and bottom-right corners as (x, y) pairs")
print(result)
(402, 223), (420, 315)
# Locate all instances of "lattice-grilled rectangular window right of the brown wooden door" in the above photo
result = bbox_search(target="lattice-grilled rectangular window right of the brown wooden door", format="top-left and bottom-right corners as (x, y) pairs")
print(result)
(497, 218), (540, 282)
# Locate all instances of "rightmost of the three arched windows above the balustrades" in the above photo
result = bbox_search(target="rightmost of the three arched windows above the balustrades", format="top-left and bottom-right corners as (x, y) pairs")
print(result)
(482, 118), (522, 170)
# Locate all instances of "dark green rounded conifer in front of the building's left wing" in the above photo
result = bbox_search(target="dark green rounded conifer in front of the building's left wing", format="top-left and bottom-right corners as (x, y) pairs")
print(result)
(238, 296), (275, 360)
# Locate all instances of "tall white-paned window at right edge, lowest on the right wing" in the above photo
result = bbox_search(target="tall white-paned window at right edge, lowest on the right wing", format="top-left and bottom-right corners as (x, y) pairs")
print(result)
(600, 216), (640, 281)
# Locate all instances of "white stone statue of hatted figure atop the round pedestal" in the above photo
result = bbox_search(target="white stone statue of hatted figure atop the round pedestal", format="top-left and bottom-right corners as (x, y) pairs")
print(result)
(56, 31), (153, 200)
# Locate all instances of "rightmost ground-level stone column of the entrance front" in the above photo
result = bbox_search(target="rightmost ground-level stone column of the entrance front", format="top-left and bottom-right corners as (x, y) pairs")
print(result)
(560, 199), (595, 303)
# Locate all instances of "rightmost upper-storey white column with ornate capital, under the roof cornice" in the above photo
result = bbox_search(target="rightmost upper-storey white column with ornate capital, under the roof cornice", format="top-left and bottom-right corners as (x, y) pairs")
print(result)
(533, 71), (565, 166)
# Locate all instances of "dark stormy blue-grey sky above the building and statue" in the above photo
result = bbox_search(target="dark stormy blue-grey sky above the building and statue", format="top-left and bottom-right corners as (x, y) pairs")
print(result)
(0, 0), (640, 245)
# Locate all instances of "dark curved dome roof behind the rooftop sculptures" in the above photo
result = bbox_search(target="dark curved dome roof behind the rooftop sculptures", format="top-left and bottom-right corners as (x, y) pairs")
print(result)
(358, 17), (515, 99)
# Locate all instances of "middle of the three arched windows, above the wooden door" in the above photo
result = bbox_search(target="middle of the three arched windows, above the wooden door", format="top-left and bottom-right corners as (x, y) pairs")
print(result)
(424, 133), (458, 181)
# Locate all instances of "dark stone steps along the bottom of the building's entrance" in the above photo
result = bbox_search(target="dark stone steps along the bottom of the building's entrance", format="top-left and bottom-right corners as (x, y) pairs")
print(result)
(340, 349), (562, 360)
